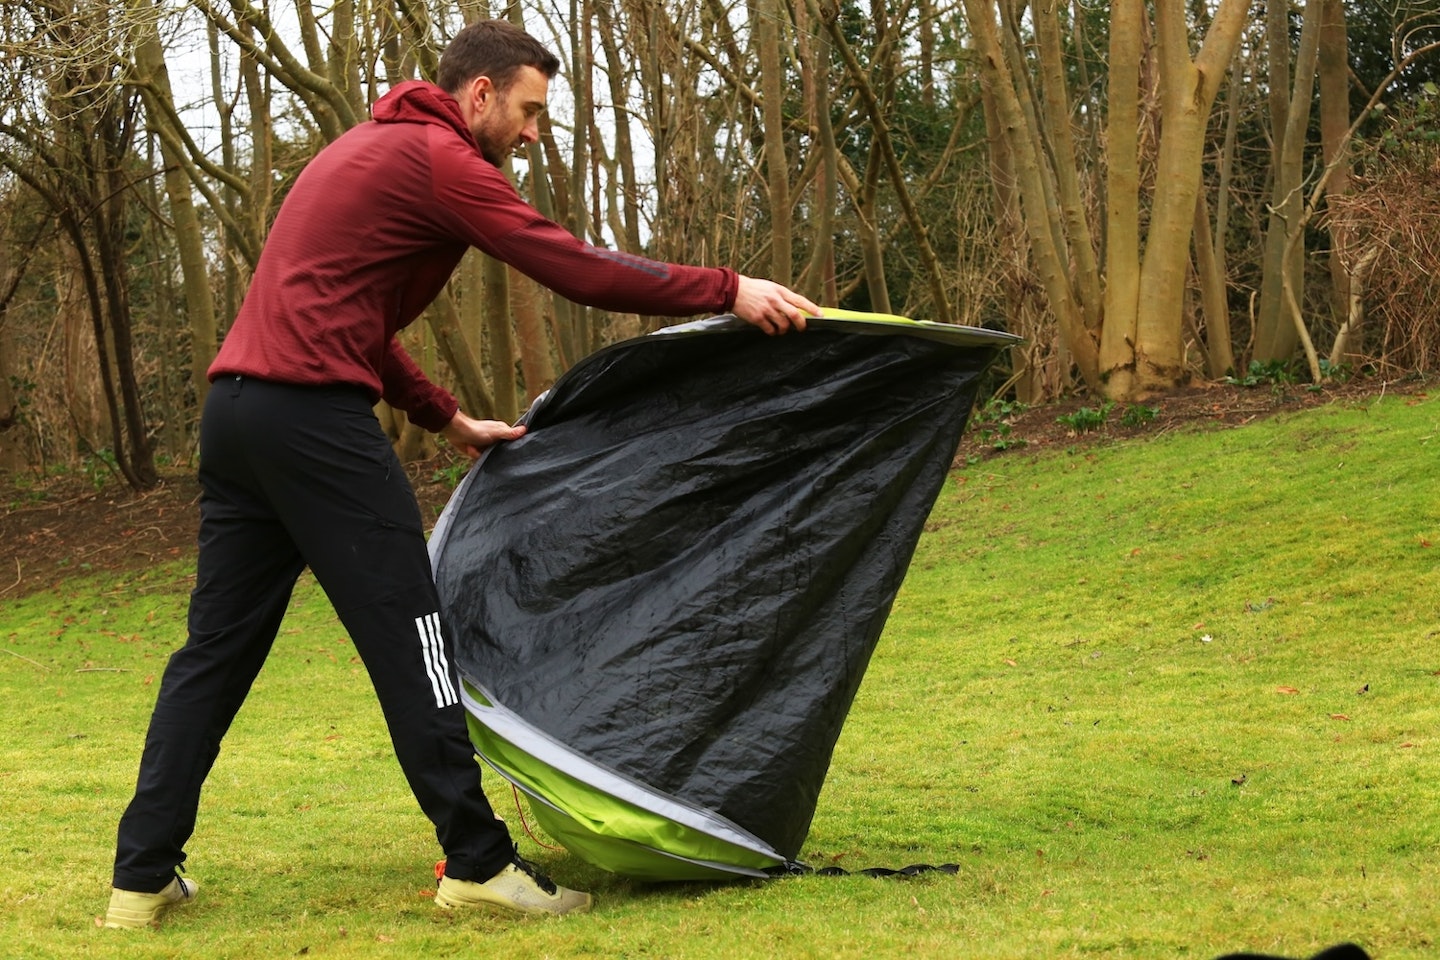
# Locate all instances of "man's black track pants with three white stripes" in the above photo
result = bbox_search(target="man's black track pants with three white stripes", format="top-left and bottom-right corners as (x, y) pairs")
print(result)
(114, 377), (513, 891)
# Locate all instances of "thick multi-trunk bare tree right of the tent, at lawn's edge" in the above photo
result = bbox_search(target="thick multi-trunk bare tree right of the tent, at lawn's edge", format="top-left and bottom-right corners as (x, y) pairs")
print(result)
(965, 0), (1247, 400)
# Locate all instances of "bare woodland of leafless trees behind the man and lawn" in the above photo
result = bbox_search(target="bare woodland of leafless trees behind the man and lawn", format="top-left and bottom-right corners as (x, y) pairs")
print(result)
(0, 0), (1440, 489)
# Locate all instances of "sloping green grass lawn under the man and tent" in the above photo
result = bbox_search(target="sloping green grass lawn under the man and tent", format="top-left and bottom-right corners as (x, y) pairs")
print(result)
(0, 399), (1440, 959)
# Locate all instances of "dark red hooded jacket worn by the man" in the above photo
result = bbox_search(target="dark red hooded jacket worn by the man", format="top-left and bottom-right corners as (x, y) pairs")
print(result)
(209, 81), (739, 430)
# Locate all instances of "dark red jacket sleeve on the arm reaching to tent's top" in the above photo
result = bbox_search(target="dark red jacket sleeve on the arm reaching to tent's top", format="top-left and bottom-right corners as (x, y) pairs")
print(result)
(431, 128), (739, 317)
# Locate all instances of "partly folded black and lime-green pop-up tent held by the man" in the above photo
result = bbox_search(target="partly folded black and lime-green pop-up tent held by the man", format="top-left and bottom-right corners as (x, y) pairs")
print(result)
(431, 311), (1015, 879)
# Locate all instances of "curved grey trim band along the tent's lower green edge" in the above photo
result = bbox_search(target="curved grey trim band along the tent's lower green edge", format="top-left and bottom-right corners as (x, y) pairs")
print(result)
(461, 678), (785, 877)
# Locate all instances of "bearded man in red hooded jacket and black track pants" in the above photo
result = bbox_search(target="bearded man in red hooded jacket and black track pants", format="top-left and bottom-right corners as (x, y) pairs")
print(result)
(105, 20), (819, 927)
